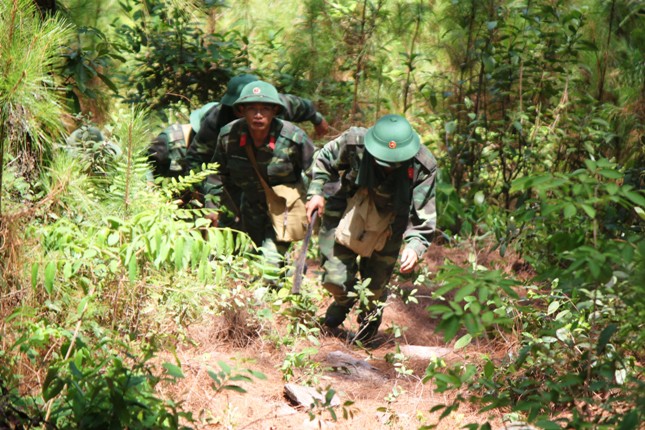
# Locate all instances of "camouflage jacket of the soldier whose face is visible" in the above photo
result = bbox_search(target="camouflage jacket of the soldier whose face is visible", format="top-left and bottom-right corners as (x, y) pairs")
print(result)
(204, 118), (314, 206)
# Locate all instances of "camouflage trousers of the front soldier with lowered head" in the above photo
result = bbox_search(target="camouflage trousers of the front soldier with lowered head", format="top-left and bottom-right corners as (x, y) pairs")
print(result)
(318, 197), (407, 311)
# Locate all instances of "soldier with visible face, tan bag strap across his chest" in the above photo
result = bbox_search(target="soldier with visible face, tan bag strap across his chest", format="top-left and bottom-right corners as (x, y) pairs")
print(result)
(209, 81), (314, 280)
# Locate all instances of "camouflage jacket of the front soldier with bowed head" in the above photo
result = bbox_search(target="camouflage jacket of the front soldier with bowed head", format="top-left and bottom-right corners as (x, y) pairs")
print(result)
(307, 127), (437, 257)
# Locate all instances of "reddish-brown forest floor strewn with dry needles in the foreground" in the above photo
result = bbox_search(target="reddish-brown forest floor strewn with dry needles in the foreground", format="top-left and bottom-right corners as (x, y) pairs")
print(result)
(156, 246), (524, 430)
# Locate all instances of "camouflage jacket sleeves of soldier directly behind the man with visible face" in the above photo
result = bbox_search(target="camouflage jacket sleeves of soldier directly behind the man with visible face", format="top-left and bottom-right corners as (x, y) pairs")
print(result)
(185, 94), (323, 174)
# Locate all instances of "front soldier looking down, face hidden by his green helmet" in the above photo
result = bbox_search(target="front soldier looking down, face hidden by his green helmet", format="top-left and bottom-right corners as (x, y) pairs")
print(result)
(307, 115), (437, 342)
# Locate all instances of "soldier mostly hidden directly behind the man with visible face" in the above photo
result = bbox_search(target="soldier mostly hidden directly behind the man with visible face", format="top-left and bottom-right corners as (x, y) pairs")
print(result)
(184, 74), (329, 225)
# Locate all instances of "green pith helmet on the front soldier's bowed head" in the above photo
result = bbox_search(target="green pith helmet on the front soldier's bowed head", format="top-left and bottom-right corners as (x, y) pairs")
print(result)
(365, 114), (421, 166)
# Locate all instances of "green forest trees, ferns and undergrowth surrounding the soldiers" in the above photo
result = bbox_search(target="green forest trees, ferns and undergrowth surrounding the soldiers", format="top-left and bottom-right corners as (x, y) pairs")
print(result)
(0, 0), (645, 430)
